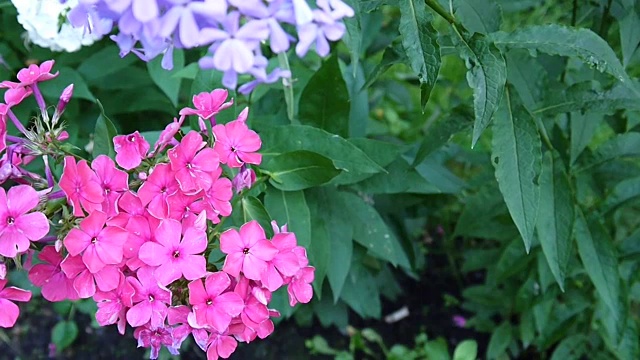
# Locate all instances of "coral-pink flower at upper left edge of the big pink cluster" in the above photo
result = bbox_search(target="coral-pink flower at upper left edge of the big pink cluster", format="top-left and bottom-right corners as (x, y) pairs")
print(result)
(60, 156), (104, 217)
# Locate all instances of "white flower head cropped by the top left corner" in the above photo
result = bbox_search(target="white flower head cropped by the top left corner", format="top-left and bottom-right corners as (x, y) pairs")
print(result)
(11, 0), (102, 52)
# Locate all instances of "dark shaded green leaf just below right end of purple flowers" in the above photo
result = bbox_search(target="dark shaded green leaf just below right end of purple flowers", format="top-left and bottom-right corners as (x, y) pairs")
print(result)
(298, 56), (351, 137)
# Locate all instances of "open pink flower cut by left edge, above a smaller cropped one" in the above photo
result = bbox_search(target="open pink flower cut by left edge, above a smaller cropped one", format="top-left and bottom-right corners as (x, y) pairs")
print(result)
(0, 185), (49, 257)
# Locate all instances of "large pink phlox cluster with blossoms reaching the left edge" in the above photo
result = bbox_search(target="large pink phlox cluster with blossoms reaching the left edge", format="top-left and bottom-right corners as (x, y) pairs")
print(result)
(0, 60), (314, 359)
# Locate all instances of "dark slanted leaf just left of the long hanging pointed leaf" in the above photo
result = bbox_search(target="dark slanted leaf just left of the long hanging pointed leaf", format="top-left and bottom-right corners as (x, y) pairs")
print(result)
(413, 105), (472, 166)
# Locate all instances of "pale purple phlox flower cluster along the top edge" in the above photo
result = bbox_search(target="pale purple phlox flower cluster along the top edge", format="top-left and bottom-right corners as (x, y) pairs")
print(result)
(61, 0), (354, 92)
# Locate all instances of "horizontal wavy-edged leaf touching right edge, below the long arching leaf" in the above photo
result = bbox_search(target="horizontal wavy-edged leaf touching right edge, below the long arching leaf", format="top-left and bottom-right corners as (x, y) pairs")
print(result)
(533, 82), (640, 115)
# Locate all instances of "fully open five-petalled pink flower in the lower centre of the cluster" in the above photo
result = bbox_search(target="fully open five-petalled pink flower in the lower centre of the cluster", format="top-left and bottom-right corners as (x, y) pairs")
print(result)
(138, 218), (207, 286)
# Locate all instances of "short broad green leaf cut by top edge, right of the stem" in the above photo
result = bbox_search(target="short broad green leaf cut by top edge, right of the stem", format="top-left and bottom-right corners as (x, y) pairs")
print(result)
(454, 0), (502, 35)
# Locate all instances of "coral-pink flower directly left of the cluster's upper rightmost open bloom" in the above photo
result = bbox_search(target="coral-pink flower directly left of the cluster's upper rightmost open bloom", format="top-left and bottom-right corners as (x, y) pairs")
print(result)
(168, 131), (219, 194)
